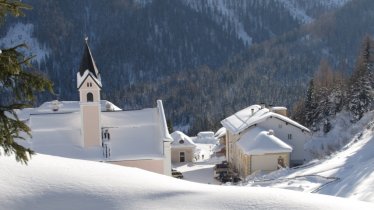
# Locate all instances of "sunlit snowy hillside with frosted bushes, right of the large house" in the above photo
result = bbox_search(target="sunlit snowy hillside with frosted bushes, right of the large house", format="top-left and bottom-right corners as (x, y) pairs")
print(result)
(244, 112), (374, 202)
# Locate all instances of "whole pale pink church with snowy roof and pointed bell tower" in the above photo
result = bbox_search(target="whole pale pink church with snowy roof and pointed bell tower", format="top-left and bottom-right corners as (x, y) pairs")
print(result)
(23, 41), (172, 175)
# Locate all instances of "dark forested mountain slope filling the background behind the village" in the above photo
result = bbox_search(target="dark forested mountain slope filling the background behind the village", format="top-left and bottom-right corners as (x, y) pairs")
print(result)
(0, 0), (360, 133)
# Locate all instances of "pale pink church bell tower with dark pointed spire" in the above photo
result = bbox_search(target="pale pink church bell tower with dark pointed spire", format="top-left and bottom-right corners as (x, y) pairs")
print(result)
(77, 38), (102, 147)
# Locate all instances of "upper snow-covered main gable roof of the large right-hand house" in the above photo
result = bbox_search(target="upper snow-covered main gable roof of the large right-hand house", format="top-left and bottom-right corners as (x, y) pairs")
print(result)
(221, 105), (310, 134)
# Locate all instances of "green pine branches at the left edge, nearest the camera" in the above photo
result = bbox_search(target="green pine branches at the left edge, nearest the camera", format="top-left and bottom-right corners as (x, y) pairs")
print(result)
(0, 0), (52, 164)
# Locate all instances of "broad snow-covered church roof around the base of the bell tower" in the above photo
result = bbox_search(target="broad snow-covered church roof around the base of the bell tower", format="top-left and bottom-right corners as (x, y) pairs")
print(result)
(26, 102), (171, 161)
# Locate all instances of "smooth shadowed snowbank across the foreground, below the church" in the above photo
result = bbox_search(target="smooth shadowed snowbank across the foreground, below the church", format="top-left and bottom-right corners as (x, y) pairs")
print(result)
(0, 154), (374, 210)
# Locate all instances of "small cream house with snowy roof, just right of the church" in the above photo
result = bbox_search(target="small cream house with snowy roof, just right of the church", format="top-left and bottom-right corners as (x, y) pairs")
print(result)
(171, 131), (197, 163)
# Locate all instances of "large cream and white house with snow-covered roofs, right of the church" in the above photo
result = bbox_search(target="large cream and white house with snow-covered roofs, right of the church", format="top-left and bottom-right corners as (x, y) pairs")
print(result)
(221, 105), (311, 177)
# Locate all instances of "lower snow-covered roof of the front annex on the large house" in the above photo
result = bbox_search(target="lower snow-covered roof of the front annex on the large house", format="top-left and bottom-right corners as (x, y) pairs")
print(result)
(236, 128), (292, 155)
